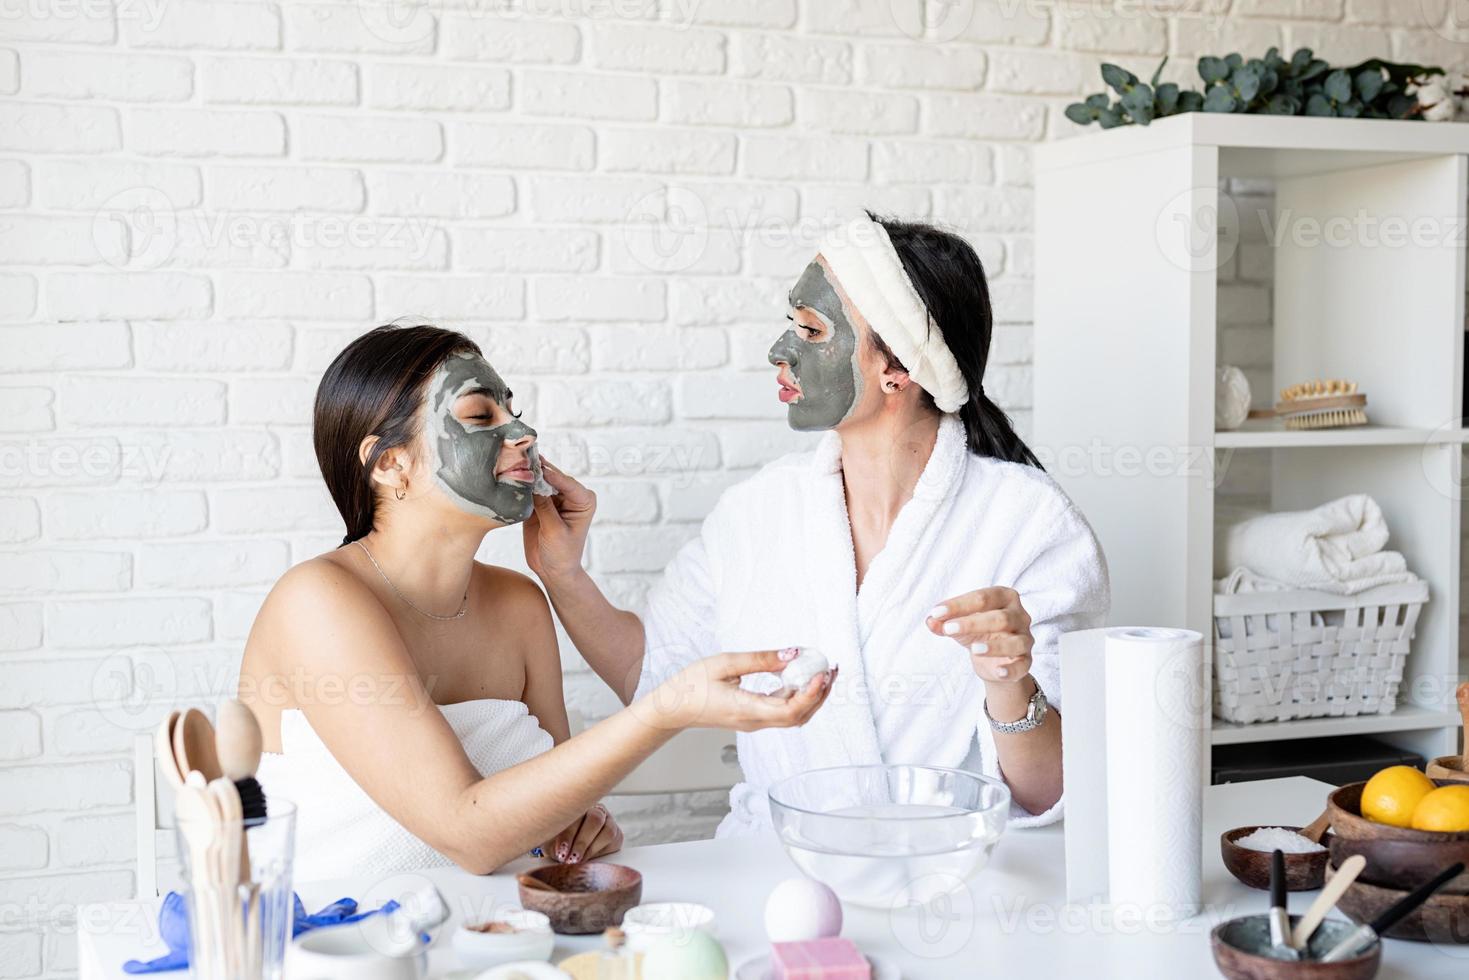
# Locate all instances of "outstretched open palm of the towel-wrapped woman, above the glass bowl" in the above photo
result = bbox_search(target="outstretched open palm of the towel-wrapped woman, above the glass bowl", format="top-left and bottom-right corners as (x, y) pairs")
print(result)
(632, 649), (836, 732)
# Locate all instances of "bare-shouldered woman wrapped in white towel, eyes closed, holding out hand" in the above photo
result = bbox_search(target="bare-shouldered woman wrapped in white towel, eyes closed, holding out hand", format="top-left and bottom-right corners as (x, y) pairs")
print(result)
(239, 325), (829, 880)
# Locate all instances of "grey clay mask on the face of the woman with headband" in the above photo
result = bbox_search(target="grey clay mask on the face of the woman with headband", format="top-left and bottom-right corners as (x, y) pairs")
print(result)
(770, 262), (862, 432)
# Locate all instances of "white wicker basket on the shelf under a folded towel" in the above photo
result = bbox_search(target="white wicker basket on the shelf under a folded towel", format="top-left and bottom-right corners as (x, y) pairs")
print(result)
(1213, 582), (1428, 723)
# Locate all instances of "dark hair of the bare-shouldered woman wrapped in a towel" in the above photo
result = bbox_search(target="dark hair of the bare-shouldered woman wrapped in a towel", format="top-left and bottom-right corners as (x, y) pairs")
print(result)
(311, 325), (480, 545)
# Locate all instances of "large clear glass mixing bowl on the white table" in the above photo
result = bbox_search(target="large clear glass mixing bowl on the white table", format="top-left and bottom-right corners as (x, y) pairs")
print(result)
(770, 765), (1011, 908)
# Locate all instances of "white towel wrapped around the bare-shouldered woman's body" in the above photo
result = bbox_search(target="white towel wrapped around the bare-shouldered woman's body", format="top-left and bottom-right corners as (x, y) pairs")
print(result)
(259, 698), (552, 882)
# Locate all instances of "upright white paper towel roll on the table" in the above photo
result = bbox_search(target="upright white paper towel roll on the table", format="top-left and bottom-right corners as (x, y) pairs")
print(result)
(1103, 627), (1209, 920)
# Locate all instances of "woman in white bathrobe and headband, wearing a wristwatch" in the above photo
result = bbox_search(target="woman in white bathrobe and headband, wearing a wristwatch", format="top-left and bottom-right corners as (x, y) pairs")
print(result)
(526, 216), (1109, 836)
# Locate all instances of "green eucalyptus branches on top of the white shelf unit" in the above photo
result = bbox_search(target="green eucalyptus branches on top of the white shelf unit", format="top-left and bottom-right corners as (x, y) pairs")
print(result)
(1066, 47), (1443, 129)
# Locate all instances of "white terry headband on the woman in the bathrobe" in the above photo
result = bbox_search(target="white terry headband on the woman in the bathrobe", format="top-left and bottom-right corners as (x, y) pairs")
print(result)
(820, 215), (970, 411)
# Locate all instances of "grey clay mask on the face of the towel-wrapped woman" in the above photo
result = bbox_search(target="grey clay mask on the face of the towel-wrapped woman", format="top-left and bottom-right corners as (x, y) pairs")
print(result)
(425, 354), (555, 525)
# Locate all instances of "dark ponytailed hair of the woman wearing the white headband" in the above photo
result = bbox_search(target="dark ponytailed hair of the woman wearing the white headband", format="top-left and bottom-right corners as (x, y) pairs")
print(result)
(868, 212), (1044, 469)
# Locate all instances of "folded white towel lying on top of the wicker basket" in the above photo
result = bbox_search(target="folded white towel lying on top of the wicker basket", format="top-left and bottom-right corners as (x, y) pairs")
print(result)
(1213, 494), (1416, 595)
